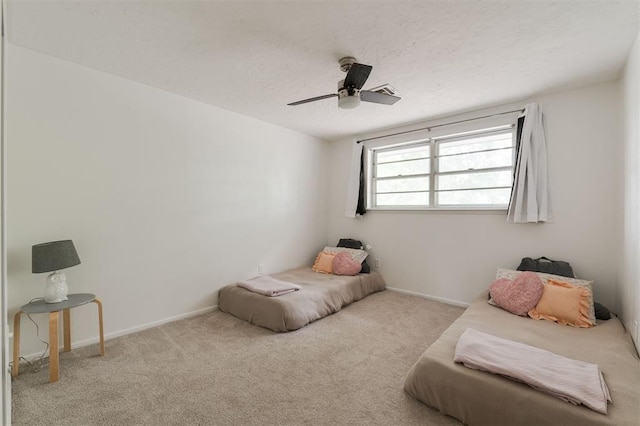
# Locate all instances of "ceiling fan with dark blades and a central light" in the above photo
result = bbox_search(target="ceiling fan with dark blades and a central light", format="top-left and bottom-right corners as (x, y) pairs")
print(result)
(287, 56), (400, 109)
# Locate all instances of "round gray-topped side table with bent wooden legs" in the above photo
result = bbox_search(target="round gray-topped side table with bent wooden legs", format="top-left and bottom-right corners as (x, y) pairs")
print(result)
(11, 293), (104, 383)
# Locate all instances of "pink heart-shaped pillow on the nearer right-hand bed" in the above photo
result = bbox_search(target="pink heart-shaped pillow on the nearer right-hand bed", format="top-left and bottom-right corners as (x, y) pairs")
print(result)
(489, 272), (544, 315)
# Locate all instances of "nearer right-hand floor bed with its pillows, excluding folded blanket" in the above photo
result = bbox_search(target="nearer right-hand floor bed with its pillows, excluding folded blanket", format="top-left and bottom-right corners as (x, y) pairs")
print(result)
(405, 270), (640, 425)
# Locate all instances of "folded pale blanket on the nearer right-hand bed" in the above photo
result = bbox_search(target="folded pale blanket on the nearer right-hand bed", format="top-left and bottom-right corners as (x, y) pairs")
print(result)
(453, 328), (612, 414)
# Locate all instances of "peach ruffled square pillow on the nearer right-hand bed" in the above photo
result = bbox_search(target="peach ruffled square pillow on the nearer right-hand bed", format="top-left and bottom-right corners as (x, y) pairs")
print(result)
(529, 279), (595, 328)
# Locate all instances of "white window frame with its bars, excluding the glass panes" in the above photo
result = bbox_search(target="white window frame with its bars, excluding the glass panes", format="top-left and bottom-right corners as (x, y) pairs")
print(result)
(363, 121), (517, 213)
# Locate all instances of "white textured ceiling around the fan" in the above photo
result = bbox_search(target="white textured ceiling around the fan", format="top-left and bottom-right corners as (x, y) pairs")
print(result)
(7, 0), (640, 139)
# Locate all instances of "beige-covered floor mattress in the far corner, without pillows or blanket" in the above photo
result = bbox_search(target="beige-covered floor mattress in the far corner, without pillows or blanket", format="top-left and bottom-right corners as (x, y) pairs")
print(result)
(218, 267), (385, 331)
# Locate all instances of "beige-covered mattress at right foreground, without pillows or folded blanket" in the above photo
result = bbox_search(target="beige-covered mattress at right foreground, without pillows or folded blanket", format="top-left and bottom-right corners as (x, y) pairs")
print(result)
(405, 293), (640, 426)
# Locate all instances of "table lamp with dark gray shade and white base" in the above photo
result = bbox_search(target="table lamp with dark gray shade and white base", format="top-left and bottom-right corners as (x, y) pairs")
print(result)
(31, 240), (80, 303)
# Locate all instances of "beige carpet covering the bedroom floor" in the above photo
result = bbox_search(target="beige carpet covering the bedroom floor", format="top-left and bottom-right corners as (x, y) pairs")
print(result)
(13, 291), (463, 425)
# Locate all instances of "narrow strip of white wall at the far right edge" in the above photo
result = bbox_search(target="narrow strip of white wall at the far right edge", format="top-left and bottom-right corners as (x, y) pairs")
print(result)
(619, 31), (640, 347)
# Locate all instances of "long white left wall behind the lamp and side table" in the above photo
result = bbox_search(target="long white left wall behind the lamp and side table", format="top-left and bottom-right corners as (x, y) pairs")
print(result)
(6, 45), (329, 354)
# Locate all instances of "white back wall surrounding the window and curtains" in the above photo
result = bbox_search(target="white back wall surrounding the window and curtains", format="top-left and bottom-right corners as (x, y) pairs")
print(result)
(329, 82), (623, 309)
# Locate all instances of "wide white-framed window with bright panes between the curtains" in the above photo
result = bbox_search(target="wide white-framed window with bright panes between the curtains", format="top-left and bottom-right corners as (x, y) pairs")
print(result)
(366, 124), (514, 209)
